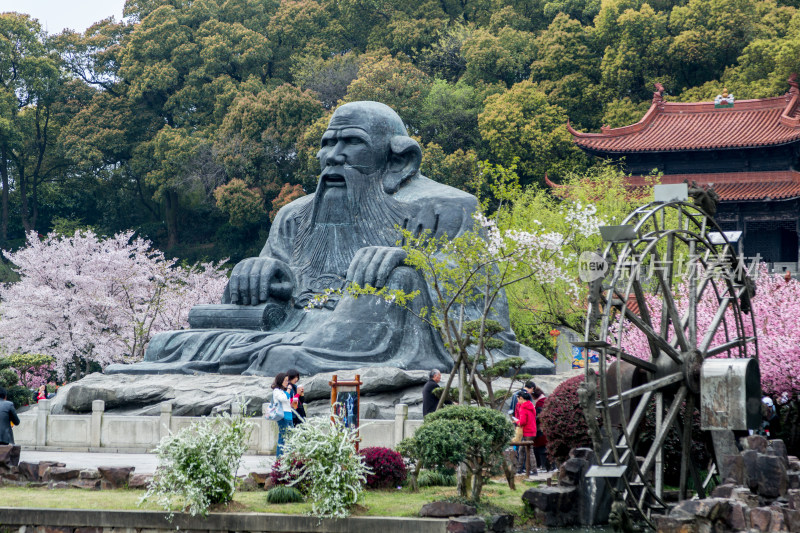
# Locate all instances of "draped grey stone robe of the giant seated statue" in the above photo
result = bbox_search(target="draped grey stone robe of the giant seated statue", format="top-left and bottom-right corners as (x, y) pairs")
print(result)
(106, 175), (535, 376)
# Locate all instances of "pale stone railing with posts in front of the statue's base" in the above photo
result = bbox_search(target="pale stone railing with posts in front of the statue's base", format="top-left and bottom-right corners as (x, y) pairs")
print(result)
(14, 400), (422, 455)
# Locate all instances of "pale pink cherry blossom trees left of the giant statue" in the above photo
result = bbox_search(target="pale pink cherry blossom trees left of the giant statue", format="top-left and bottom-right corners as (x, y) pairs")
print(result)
(0, 231), (227, 378)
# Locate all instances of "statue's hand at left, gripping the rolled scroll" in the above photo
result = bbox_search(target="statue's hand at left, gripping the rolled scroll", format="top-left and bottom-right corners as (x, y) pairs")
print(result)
(228, 257), (294, 305)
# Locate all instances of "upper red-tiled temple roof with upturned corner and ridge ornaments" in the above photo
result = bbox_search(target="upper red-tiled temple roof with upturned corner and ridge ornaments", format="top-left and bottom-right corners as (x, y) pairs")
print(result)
(567, 75), (800, 154)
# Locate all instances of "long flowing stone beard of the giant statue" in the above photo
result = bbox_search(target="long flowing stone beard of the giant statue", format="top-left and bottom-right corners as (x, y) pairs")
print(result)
(293, 167), (410, 292)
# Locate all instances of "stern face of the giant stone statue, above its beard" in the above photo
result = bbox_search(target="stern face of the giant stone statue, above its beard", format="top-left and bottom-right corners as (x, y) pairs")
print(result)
(317, 107), (388, 187)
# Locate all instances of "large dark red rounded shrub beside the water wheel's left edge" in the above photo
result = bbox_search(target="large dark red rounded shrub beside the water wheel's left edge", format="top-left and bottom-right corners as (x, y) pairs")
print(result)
(539, 375), (592, 463)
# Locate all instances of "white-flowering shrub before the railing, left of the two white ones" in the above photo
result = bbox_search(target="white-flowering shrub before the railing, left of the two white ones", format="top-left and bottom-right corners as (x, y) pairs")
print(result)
(139, 413), (254, 516)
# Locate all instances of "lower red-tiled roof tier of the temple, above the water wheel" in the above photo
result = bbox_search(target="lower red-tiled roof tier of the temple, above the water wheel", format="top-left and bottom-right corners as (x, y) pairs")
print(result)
(545, 170), (800, 201)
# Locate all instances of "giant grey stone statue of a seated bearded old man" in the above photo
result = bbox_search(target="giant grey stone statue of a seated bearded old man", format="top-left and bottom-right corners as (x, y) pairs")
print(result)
(106, 102), (552, 376)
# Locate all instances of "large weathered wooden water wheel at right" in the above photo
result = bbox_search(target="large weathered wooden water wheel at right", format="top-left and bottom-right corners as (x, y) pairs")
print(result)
(579, 192), (760, 526)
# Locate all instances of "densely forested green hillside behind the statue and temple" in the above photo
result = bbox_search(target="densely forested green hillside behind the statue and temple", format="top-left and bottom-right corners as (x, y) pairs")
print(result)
(0, 0), (800, 261)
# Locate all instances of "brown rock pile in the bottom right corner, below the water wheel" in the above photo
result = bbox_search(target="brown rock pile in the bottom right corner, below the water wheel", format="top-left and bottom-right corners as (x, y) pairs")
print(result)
(655, 435), (800, 533)
